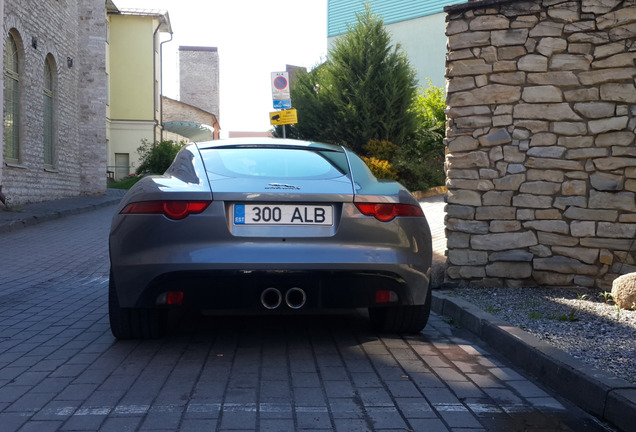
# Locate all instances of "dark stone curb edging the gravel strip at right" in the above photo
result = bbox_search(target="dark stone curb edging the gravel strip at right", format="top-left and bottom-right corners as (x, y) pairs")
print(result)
(431, 290), (636, 432)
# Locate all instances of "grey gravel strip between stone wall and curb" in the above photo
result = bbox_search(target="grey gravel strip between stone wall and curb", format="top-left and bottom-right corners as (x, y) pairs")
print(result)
(448, 288), (636, 384)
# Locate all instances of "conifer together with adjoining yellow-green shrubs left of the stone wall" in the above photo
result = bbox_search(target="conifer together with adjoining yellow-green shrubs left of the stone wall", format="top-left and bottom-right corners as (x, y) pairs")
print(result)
(275, 4), (446, 190)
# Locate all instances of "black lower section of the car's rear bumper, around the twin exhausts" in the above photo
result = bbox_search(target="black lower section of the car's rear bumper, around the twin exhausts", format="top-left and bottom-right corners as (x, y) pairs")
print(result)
(112, 270), (429, 312)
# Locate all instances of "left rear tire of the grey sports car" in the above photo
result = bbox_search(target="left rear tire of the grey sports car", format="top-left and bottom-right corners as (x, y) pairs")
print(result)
(108, 270), (166, 339)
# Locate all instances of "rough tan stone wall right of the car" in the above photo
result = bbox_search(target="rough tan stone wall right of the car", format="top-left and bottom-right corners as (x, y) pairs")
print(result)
(446, 0), (636, 290)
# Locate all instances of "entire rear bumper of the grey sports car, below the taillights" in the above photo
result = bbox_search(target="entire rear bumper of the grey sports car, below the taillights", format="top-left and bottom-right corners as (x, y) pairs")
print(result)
(110, 203), (432, 309)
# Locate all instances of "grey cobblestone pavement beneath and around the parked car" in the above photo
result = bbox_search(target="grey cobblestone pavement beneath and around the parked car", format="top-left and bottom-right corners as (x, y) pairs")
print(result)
(0, 206), (608, 432)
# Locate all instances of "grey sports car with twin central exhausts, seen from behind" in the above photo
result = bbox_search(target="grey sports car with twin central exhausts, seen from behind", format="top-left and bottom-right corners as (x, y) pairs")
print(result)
(108, 138), (432, 339)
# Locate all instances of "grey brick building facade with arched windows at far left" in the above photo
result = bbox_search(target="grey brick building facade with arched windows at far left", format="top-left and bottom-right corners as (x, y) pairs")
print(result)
(0, 0), (107, 205)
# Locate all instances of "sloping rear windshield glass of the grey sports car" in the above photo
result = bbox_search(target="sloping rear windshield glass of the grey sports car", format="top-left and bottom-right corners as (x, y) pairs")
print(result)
(201, 147), (347, 179)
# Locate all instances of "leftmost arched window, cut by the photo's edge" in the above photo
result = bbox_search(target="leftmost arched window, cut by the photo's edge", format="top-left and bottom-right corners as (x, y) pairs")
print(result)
(4, 33), (20, 162)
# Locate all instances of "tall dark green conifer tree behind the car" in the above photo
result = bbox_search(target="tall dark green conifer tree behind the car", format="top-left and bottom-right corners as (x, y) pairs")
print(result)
(276, 4), (417, 155)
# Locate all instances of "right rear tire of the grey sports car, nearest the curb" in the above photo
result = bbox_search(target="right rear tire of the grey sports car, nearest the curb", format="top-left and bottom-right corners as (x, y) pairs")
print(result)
(369, 287), (432, 333)
